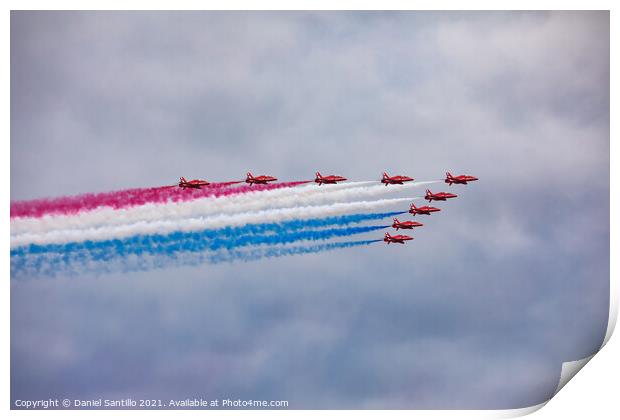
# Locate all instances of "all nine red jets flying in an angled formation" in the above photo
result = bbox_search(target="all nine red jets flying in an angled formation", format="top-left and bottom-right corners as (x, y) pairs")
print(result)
(179, 172), (478, 245)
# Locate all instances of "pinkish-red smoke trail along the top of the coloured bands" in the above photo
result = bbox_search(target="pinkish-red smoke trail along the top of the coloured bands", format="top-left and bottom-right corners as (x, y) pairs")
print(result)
(11, 181), (310, 219)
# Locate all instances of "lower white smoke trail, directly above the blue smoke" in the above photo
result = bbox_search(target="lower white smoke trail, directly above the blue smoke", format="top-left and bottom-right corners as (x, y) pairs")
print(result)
(11, 197), (422, 248)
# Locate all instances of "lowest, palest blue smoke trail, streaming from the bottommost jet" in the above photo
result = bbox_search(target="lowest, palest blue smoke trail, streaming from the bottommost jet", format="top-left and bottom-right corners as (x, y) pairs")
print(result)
(11, 239), (381, 278)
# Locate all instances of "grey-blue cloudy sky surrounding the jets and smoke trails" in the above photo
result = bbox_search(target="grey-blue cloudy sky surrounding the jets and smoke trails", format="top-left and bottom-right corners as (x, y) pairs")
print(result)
(11, 12), (609, 408)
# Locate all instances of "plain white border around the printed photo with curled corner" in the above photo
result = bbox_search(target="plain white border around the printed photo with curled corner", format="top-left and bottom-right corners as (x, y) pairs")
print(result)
(0, 0), (619, 419)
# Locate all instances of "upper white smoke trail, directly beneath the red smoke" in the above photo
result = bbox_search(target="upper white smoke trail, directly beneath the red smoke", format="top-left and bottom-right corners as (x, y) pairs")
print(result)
(11, 181), (438, 240)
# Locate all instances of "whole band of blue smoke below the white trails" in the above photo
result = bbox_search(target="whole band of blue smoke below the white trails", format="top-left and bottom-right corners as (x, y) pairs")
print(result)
(11, 212), (405, 277)
